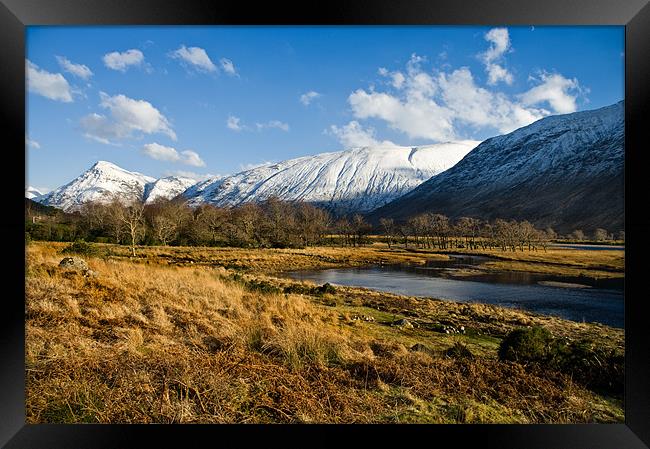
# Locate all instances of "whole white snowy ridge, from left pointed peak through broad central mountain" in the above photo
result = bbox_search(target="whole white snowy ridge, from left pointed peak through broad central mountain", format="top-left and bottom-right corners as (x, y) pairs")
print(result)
(37, 140), (479, 212)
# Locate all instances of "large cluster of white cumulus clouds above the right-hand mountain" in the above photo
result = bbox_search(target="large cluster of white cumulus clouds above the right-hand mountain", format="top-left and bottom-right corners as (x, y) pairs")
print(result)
(340, 46), (586, 143)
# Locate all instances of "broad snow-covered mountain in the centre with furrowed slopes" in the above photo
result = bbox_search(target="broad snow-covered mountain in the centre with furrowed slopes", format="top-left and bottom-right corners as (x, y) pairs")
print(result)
(183, 140), (479, 212)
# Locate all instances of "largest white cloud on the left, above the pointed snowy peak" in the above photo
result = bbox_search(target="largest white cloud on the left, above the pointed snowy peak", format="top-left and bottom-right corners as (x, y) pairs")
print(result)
(80, 92), (176, 143)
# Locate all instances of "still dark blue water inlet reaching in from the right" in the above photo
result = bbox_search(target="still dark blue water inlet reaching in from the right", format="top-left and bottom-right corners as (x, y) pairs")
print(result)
(288, 256), (624, 328)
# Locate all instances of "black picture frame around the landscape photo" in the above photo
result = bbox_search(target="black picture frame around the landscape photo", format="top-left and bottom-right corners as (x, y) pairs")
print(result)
(5, 0), (650, 449)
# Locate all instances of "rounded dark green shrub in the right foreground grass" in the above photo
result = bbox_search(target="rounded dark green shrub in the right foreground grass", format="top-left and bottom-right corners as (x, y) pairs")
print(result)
(499, 326), (553, 363)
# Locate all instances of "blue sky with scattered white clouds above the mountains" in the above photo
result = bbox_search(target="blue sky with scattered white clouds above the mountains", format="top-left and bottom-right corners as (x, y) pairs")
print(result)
(26, 26), (624, 189)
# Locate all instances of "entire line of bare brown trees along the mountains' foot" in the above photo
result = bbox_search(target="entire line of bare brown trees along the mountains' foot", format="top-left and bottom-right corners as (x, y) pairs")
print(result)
(31, 192), (624, 255)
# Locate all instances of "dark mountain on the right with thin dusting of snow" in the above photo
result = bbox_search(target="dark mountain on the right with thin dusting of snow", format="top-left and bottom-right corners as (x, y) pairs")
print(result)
(369, 101), (624, 232)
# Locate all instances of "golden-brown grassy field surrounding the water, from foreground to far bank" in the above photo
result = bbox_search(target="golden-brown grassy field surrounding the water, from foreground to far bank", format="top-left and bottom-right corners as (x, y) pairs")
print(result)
(25, 242), (624, 423)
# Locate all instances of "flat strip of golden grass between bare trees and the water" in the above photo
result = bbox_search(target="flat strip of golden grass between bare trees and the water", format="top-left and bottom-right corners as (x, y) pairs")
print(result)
(72, 242), (625, 278)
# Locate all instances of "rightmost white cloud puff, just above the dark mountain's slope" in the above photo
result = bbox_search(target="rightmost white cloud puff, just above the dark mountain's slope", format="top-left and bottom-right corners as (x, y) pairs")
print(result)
(520, 72), (582, 114)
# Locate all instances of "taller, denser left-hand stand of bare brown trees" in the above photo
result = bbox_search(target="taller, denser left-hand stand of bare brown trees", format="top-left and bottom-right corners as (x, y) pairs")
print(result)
(80, 198), (331, 255)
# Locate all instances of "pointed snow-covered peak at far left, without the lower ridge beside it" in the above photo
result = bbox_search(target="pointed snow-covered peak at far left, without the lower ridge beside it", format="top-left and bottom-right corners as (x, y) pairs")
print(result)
(38, 161), (156, 211)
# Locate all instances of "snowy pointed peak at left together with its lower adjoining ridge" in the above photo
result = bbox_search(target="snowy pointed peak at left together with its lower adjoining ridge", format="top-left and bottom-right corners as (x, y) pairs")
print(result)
(37, 161), (194, 211)
